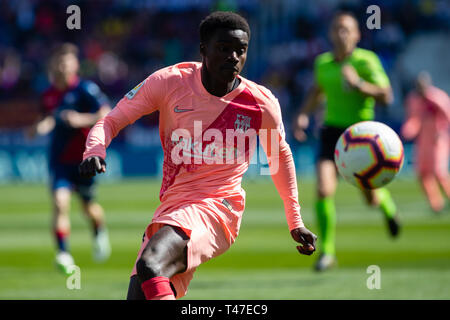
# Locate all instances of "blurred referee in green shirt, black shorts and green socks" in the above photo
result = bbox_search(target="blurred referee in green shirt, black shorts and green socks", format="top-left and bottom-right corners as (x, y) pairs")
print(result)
(294, 12), (399, 271)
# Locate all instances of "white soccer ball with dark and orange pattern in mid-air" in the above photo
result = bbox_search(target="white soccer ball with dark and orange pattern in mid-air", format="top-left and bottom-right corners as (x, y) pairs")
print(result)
(334, 121), (404, 189)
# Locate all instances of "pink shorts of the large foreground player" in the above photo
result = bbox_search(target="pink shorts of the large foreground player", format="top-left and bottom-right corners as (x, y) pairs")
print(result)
(131, 199), (241, 299)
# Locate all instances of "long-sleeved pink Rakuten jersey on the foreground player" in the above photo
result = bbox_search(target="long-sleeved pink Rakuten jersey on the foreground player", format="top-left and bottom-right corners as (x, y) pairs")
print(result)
(83, 62), (304, 240)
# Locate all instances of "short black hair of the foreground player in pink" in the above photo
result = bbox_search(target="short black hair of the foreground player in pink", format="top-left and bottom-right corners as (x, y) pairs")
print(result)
(200, 11), (250, 42)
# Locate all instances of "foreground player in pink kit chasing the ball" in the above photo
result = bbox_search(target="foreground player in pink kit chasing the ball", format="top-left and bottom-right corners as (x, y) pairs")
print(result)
(80, 12), (316, 300)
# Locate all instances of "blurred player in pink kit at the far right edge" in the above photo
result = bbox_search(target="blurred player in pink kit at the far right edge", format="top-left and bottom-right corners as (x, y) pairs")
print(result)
(401, 72), (450, 212)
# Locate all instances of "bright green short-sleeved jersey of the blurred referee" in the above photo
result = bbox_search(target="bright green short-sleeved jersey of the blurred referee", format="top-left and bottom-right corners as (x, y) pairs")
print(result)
(314, 48), (390, 128)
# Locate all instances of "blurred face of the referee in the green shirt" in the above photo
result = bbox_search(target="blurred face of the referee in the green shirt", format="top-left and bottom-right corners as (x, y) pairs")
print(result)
(330, 15), (360, 53)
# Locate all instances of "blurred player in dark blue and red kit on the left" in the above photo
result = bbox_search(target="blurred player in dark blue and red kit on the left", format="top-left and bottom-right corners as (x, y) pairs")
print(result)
(28, 43), (111, 273)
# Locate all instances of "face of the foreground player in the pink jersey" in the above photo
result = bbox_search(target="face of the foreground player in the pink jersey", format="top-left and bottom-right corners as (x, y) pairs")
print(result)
(200, 29), (249, 83)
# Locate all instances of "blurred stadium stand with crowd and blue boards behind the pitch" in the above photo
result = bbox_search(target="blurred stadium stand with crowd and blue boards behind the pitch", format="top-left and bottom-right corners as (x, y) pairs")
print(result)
(0, 0), (450, 183)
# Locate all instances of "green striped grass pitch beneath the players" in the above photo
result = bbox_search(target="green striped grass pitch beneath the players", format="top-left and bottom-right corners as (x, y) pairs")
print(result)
(0, 177), (450, 300)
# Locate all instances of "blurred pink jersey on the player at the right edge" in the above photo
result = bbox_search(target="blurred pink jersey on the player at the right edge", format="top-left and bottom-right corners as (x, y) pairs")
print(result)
(402, 86), (450, 173)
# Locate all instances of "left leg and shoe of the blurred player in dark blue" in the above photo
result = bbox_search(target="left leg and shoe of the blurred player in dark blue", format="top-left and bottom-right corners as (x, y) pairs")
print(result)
(52, 187), (74, 273)
